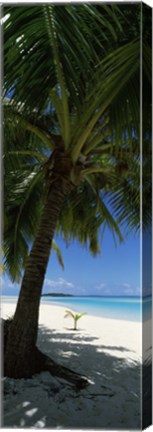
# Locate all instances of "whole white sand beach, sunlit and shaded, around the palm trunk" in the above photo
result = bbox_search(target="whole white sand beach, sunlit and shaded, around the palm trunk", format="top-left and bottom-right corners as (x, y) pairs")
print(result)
(1, 302), (142, 429)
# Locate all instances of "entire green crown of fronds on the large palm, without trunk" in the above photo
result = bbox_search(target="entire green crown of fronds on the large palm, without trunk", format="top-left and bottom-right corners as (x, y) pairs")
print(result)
(3, 4), (151, 280)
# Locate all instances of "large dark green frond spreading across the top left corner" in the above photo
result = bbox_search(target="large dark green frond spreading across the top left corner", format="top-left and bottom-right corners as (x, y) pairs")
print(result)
(3, 4), (120, 112)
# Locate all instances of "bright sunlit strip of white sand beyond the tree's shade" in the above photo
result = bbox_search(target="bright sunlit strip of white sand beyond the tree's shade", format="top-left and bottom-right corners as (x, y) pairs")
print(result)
(1, 301), (142, 361)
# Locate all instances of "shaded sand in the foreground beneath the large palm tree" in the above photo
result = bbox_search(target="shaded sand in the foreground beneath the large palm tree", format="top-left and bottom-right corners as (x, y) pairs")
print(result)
(3, 326), (151, 430)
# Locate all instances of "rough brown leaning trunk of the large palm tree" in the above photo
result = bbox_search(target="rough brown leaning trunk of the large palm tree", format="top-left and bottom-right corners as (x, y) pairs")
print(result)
(4, 152), (72, 378)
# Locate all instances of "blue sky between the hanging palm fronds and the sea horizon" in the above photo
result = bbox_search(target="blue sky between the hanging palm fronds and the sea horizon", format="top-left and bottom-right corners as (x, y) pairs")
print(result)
(2, 226), (145, 295)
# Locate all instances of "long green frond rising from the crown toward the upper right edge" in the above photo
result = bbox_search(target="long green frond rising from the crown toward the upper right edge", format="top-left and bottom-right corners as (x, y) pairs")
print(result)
(72, 41), (140, 162)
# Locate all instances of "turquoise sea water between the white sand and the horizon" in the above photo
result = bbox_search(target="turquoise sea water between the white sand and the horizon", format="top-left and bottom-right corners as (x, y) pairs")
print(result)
(41, 297), (152, 321)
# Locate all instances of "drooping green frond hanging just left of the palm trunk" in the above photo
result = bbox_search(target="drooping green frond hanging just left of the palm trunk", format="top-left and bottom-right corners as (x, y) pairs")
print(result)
(3, 171), (43, 281)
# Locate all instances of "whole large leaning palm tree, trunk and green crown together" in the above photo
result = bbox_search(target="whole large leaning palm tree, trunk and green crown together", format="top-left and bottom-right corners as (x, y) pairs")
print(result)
(4, 5), (151, 386)
